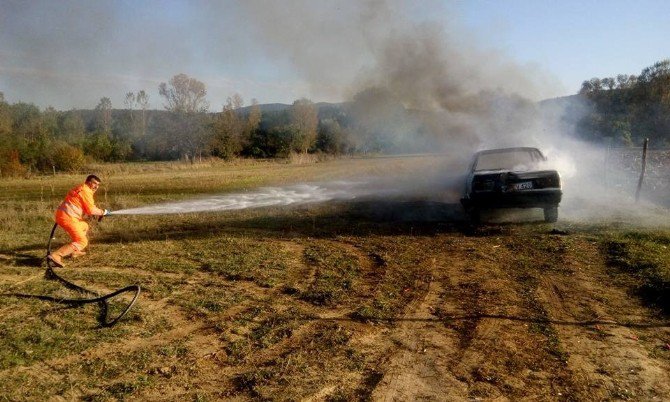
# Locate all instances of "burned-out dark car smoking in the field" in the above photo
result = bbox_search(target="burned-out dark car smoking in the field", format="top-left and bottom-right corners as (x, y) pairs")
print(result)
(461, 147), (563, 222)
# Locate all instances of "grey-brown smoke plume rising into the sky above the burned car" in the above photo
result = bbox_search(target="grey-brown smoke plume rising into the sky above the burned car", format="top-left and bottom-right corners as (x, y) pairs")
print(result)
(240, 1), (560, 155)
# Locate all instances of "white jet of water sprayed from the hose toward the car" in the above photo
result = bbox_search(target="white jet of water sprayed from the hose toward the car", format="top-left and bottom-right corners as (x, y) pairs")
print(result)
(114, 181), (398, 215)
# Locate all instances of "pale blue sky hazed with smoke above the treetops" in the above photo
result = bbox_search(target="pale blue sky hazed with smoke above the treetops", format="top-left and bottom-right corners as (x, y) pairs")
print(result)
(0, 0), (670, 111)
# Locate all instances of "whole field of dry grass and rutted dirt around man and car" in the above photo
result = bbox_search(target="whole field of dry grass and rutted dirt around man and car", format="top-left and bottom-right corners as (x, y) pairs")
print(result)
(0, 156), (670, 401)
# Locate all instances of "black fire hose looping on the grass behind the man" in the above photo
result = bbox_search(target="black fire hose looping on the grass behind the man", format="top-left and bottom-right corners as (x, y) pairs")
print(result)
(2, 218), (140, 328)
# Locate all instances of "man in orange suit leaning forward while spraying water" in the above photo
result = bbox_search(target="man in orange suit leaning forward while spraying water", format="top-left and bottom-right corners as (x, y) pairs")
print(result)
(47, 175), (109, 267)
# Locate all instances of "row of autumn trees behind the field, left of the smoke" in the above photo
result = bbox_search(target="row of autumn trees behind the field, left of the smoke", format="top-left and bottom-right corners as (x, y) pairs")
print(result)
(0, 74), (362, 176)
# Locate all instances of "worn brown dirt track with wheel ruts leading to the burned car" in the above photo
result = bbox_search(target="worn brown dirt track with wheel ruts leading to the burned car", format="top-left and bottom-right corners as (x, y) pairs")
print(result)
(373, 228), (670, 400)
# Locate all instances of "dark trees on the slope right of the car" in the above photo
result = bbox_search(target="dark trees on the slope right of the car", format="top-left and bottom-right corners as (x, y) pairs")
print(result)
(577, 60), (670, 148)
